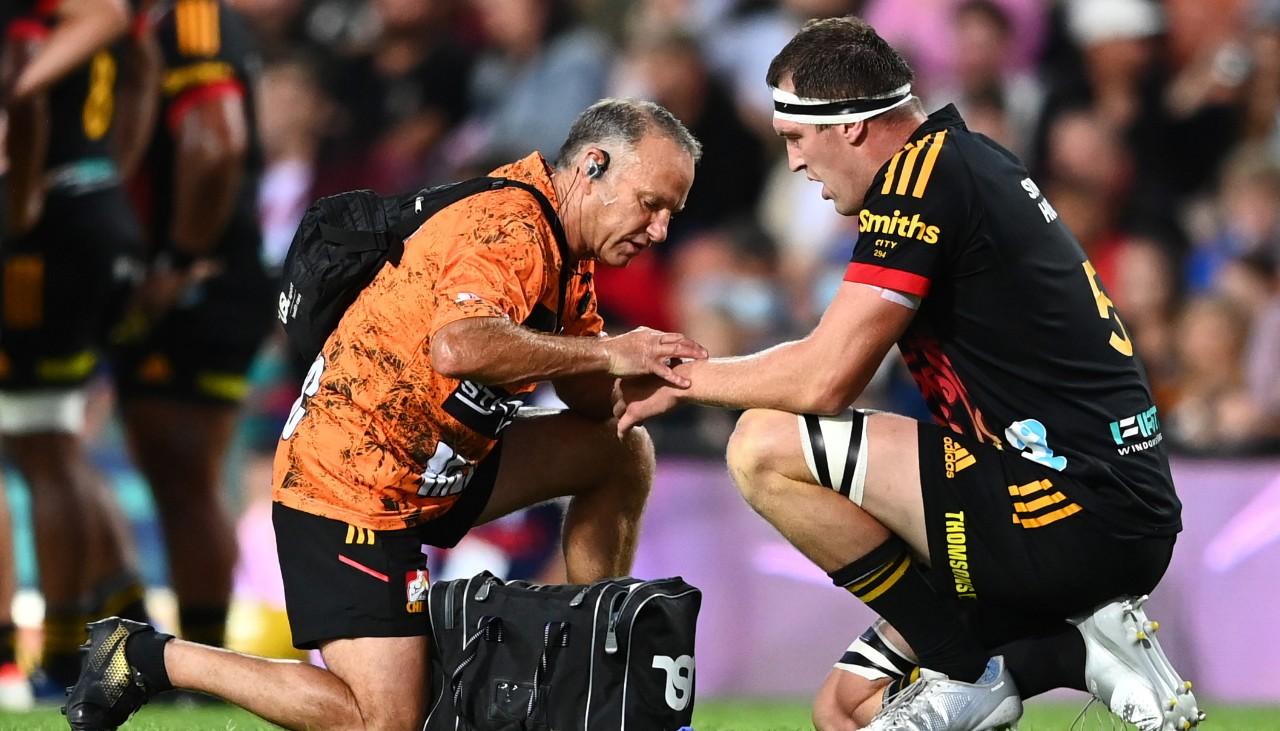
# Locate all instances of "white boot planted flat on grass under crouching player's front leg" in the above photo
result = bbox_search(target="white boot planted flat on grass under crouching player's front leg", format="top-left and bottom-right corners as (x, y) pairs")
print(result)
(865, 655), (1023, 731)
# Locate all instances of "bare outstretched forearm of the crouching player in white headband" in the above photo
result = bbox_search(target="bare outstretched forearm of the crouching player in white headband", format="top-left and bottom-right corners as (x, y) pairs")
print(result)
(676, 339), (878, 415)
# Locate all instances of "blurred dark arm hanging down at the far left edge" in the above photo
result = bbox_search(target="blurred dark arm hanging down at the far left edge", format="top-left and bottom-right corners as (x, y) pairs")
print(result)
(5, 93), (49, 233)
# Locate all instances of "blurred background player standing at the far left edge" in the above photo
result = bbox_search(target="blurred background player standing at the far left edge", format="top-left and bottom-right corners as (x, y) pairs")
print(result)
(0, 0), (146, 696)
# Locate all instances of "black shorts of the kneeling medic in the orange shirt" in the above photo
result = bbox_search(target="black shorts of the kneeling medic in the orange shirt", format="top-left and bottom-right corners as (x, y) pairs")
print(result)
(271, 442), (502, 649)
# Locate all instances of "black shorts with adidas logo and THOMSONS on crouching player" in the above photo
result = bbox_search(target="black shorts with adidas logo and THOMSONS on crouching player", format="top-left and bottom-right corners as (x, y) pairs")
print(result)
(919, 424), (1174, 648)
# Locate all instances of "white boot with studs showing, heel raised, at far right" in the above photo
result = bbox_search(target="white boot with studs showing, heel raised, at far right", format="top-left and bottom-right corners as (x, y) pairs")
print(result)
(1071, 595), (1204, 731)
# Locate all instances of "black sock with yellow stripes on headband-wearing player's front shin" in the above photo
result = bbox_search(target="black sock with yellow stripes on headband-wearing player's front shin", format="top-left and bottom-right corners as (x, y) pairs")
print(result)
(829, 535), (988, 682)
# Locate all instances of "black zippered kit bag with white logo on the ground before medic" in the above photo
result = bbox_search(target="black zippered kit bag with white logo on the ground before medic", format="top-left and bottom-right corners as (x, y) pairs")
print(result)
(425, 571), (703, 731)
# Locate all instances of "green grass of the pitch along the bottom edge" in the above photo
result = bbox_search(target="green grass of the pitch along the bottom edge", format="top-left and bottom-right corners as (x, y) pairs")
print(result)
(0, 700), (1280, 731)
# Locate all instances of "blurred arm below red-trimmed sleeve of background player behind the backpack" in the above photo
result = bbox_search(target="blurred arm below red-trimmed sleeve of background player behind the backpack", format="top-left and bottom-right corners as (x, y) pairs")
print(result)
(169, 123), (244, 256)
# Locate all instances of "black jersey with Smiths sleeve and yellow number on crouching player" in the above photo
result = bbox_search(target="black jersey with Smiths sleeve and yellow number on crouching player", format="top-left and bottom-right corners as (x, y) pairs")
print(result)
(845, 106), (1181, 535)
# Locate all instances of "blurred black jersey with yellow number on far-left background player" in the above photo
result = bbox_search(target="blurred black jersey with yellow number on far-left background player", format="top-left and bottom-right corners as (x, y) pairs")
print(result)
(4, 0), (119, 195)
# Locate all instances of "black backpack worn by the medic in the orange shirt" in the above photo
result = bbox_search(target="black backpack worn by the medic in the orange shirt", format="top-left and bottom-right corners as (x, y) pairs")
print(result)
(276, 178), (571, 362)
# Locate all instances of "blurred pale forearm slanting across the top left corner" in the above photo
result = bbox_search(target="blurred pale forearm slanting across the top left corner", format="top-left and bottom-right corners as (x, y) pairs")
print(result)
(10, 0), (129, 101)
